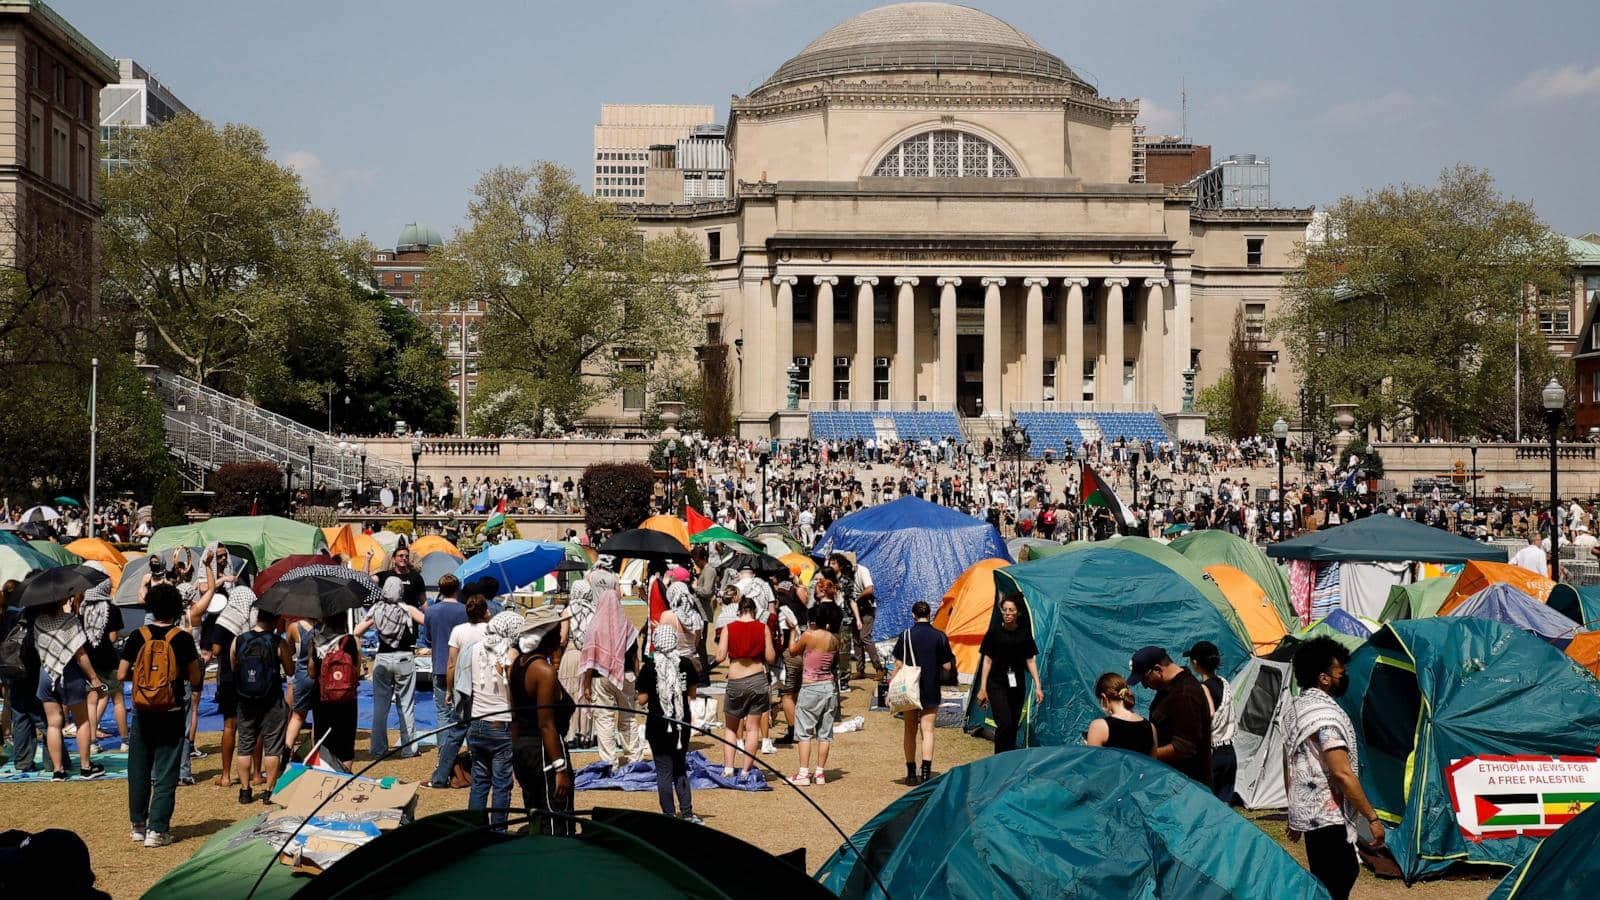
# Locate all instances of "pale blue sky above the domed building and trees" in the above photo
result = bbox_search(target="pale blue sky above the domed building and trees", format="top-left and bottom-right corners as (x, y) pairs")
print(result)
(51, 0), (1600, 245)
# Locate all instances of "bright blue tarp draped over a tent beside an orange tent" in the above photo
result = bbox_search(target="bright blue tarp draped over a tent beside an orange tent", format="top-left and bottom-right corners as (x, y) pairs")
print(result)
(813, 496), (1011, 641)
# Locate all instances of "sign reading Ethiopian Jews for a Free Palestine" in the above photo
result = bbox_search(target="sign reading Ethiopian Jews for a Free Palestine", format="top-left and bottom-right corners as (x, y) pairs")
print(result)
(1445, 756), (1600, 841)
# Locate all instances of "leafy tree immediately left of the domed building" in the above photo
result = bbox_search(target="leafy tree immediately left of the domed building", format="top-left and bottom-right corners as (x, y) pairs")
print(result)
(422, 162), (706, 434)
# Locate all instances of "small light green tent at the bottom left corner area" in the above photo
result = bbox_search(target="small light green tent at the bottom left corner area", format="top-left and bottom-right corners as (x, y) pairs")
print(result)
(144, 815), (312, 900)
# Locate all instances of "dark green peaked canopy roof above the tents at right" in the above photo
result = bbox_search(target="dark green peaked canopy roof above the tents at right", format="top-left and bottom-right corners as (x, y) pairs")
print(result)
(1267, 516), (1507, 562)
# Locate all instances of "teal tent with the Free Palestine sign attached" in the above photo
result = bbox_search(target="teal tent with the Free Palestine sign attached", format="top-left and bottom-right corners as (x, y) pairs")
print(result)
(1339, 617), (1600, 882)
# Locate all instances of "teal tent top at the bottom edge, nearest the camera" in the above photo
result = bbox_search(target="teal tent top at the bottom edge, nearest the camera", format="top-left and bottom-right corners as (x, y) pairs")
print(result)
(816, 743), (1328, 900)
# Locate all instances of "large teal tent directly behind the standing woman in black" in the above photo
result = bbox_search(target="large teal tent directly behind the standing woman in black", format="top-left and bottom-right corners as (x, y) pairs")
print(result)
(966, 541), (1251, 746)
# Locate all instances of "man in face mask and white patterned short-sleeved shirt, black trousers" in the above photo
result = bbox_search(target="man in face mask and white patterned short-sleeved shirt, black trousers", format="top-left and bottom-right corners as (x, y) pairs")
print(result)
(1283, 637), (1384, 900)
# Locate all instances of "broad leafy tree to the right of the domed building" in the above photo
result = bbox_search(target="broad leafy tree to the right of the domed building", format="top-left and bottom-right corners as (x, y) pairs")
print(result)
(1274, 167), (1571, 434)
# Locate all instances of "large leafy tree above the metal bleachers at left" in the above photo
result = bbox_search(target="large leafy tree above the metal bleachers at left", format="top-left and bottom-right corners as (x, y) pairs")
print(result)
(102, 115), (382, 402)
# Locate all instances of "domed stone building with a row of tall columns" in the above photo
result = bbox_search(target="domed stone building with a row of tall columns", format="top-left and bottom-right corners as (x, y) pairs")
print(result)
(617, 3), (1310, 437)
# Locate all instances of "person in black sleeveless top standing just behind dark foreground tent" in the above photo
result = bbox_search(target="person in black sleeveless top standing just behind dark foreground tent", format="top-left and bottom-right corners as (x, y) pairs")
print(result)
(510, 605), (578, 836)
